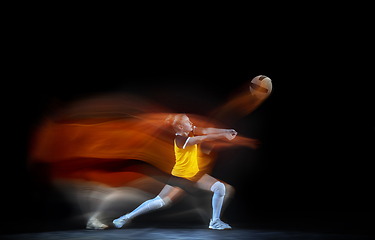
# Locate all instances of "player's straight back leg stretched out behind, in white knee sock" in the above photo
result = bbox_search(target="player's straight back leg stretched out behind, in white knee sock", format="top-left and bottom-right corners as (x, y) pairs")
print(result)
(113, 185), (182, 228)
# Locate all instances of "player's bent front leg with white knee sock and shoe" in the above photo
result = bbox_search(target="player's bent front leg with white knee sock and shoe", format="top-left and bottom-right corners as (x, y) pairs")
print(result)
(197, 174), (232, 230)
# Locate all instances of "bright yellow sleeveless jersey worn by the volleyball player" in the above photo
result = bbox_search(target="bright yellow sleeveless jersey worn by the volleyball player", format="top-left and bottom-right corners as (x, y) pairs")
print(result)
(172, 136), (199, 180)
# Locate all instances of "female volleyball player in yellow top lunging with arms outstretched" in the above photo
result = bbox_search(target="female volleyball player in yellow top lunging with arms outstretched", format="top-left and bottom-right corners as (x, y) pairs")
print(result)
(113, 114), (237, 230)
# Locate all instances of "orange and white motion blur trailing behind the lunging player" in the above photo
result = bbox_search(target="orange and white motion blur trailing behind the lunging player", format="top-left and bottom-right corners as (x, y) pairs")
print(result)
(29, 91), (258, 229)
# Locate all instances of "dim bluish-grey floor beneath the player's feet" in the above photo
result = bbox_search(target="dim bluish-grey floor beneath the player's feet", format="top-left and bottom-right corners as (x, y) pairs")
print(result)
(0, 226), (373, 240)
